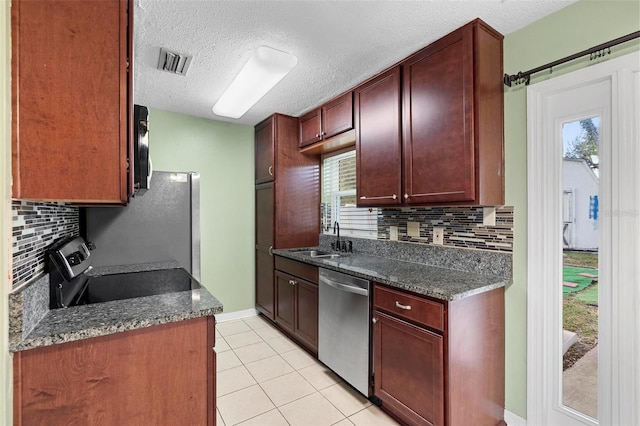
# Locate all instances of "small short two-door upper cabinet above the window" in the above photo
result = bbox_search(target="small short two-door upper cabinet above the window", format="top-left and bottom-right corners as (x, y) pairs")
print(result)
(299, 92), (353, 148)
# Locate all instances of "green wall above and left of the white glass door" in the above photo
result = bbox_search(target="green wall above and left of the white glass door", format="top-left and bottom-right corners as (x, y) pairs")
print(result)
(504, 0), (640, 418)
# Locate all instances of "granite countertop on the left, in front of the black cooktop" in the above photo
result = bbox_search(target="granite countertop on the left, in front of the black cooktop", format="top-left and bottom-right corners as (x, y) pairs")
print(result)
(9, 262), (222, 352)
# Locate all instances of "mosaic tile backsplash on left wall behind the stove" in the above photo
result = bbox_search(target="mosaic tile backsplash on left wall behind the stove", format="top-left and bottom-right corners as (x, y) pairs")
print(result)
(11, 200), (80, 289)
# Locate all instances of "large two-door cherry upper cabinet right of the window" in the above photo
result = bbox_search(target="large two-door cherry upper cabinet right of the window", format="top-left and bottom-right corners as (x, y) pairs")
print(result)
(354, 19), (504, 207)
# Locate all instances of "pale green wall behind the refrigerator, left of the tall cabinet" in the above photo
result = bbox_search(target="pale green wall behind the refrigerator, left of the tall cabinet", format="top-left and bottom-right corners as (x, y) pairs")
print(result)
(149, 110), (255, 312)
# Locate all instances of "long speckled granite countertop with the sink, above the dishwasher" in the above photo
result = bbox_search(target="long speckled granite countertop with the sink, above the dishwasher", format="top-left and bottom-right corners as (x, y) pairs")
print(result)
(273, 247), (509, 301)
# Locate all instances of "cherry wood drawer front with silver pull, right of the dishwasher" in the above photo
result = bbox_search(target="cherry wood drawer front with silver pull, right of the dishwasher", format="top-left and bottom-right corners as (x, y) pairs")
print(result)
(373, 285), (444, 331)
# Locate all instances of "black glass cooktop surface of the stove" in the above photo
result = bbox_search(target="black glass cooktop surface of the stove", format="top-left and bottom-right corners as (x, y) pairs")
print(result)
(69, 268), (200, 306)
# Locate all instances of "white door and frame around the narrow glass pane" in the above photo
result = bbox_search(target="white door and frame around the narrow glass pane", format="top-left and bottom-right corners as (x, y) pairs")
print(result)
(527, 52), (640, 425)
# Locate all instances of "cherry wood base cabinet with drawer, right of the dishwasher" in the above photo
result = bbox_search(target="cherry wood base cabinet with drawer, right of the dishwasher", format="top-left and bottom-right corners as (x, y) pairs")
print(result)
(373, 284), (504, 426)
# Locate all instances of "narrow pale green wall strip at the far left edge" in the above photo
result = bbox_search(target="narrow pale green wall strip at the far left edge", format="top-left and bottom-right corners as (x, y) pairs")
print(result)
(0, 1), (13, 425)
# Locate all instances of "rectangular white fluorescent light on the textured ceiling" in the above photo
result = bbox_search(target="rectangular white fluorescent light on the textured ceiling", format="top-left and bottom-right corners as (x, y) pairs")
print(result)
(213, 46), (298, 118)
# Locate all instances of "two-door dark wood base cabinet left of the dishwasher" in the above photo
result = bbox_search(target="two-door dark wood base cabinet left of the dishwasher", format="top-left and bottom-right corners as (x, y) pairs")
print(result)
(275, 256), (318, 354)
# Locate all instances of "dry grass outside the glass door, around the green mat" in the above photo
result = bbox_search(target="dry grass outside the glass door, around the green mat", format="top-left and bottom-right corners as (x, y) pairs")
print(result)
(562, 252), (598, 370)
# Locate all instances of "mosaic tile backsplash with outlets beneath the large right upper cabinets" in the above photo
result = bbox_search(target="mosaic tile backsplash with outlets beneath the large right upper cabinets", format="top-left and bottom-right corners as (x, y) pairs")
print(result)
(378, 206), (513, 252)
